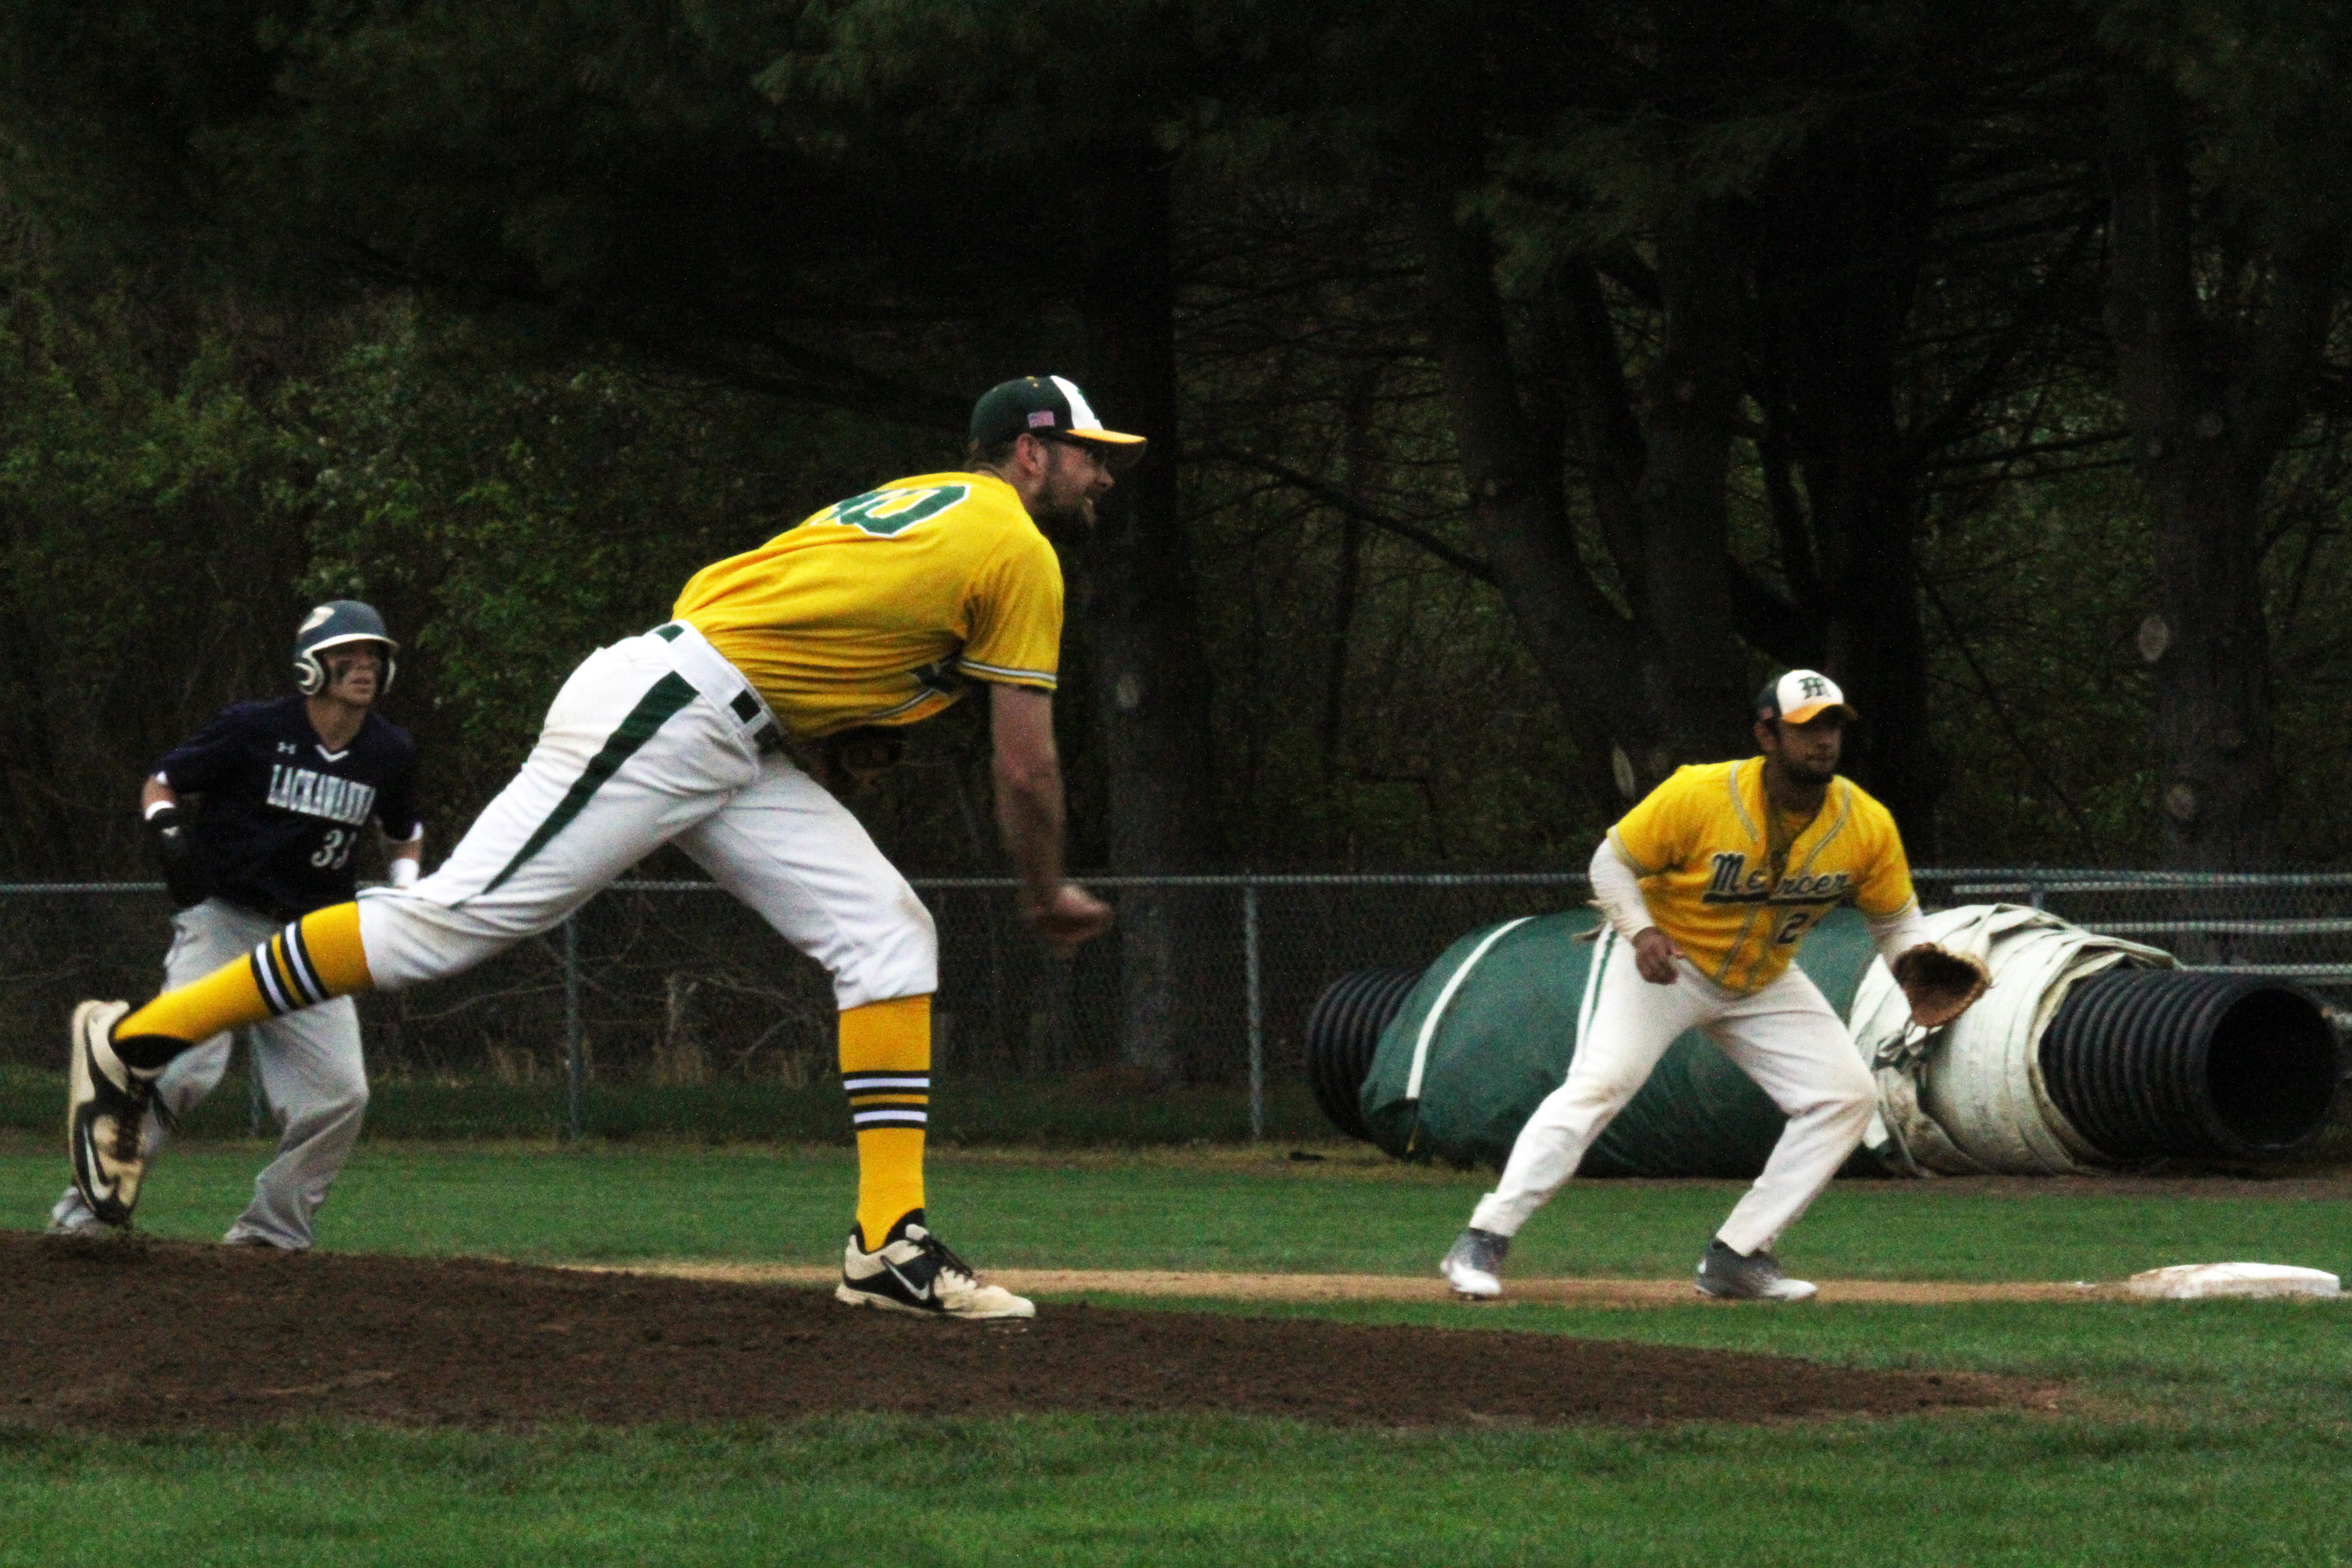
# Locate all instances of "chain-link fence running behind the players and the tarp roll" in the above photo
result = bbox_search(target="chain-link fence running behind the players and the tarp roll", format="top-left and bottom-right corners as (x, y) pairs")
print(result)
(0, 867), (2352, 1142)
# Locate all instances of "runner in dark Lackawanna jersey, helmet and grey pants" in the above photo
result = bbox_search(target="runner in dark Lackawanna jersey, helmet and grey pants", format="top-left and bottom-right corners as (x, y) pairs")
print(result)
(49, 599), (423, 1251)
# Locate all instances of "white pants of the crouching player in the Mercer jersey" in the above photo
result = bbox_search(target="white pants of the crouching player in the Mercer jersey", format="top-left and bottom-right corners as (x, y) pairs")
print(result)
(1470, 926), (1877, 1253)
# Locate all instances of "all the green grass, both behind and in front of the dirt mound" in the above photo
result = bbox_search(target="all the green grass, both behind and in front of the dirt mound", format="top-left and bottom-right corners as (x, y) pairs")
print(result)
(0, 1136), (2352, 1568)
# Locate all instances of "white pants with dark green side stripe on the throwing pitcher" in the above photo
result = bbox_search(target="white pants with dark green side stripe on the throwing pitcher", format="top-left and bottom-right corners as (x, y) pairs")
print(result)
(360, 621), (938, 1011)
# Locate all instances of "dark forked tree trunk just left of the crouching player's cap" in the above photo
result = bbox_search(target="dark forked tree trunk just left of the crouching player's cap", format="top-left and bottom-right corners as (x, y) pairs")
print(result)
(1416, 146), (1748, 792)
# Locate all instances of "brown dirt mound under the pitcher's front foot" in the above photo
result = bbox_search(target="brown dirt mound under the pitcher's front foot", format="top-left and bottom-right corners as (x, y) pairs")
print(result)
(0, 1234), (2056, 1431)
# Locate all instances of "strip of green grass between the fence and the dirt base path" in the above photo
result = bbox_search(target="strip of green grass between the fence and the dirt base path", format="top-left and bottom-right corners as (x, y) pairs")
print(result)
(0, 1136), (2352, 1279)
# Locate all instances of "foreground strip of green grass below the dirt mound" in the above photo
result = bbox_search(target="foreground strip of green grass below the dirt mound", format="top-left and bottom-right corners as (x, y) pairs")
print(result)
(0, 1417), (2352, 1568)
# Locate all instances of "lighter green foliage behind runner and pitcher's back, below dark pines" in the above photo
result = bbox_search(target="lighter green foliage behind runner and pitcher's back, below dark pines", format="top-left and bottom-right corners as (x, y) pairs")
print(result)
(0, 223), (943, 860)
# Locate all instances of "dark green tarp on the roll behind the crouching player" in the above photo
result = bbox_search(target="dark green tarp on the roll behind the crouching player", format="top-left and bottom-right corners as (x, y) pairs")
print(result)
(1362, 910), (1877, 1178)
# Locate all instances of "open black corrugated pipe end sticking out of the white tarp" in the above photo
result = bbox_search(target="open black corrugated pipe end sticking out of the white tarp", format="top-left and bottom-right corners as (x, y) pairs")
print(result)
(2042, 969), (2342, 1159)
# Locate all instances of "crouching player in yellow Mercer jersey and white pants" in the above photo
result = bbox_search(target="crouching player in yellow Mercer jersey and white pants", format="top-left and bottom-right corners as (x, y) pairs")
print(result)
(1440, 670), (1929, 1300)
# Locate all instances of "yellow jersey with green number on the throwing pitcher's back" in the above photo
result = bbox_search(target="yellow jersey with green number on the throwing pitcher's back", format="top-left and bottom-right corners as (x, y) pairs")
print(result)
(673, 472), (1061, 736)
